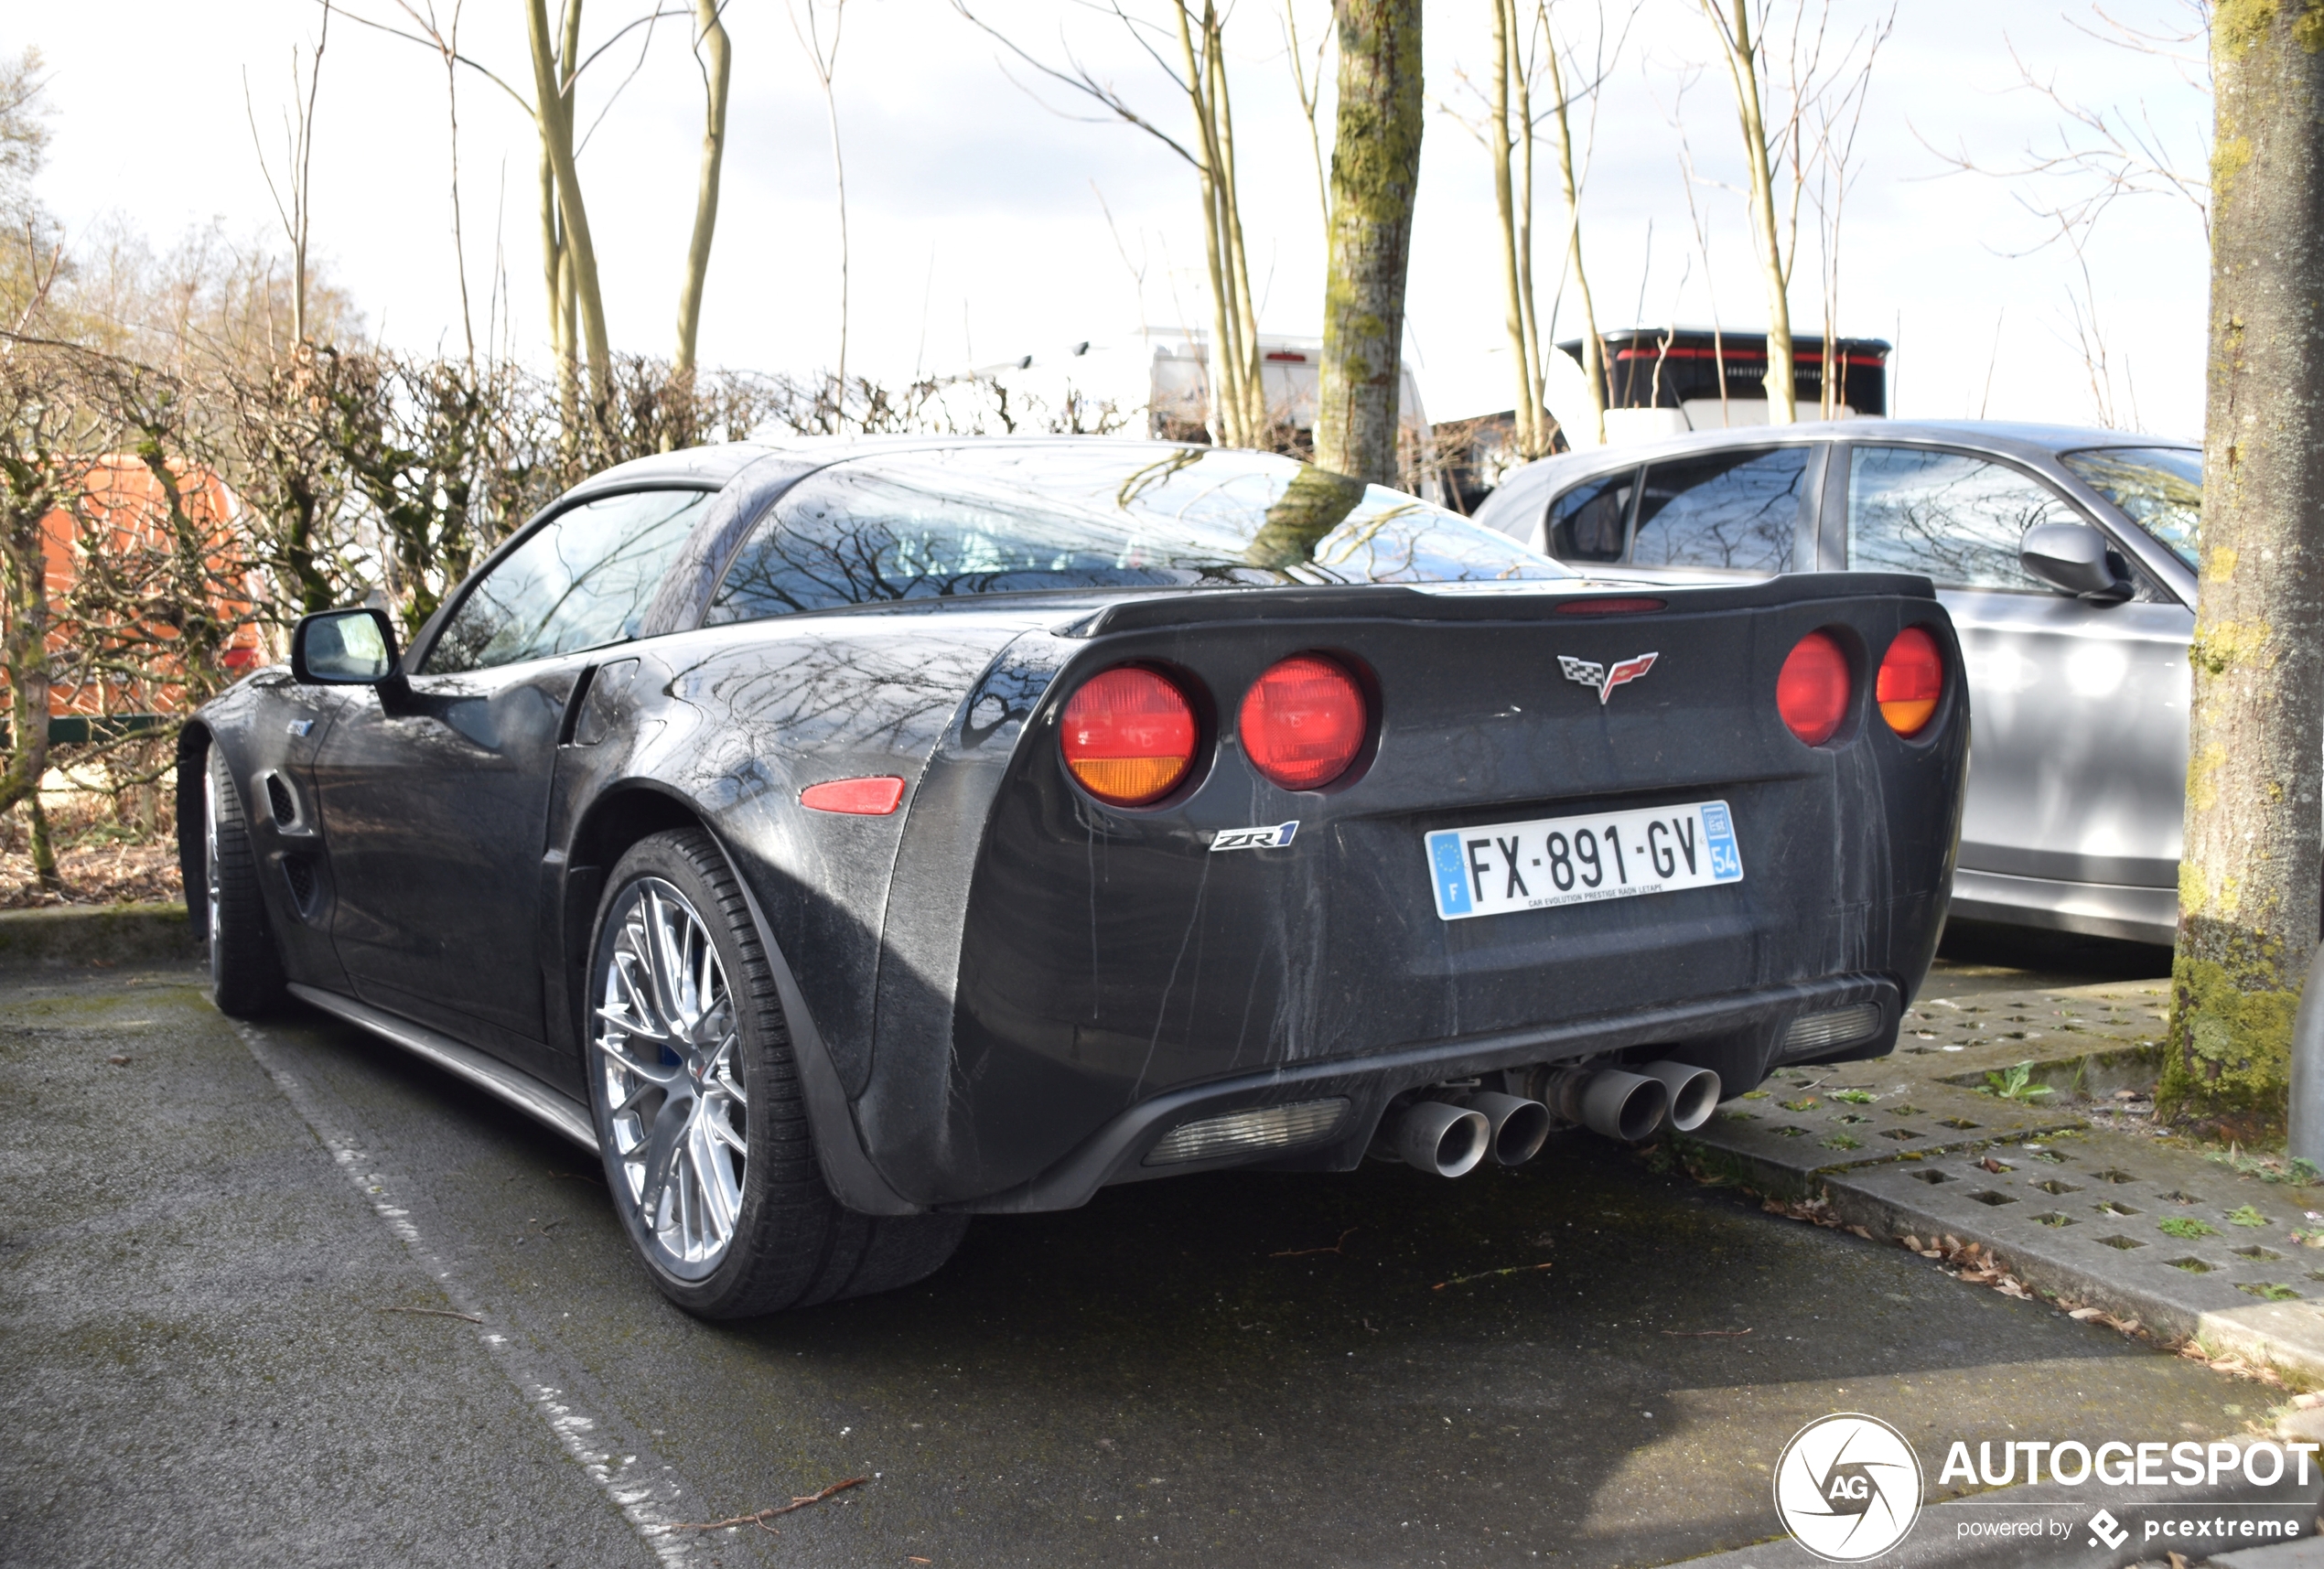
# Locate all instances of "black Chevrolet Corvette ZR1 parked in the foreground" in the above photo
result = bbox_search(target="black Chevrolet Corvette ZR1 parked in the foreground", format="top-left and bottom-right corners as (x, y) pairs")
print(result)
(179, 437), (1968, 1318)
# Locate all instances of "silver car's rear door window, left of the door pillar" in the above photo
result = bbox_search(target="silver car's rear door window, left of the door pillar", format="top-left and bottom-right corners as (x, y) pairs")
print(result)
(1630, 446), (1808, 572)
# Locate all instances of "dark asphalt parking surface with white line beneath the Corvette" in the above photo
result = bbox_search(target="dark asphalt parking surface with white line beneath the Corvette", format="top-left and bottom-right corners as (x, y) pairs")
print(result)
(0, 949), (2266, 1569)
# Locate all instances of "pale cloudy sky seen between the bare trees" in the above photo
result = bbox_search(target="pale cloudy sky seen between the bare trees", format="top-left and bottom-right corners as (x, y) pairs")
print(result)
(13, 0), (2208, 435)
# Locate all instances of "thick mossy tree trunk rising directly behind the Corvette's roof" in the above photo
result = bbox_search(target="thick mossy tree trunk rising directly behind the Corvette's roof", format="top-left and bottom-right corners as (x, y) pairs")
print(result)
(1316, 0), (1422, 483)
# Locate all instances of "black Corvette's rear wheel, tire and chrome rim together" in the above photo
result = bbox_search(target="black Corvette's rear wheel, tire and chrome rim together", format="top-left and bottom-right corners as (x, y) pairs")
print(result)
(584, 828), (969, 1318)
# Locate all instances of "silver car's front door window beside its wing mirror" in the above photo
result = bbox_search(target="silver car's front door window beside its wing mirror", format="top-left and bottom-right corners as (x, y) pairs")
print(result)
(1847, 446), (2084, 593)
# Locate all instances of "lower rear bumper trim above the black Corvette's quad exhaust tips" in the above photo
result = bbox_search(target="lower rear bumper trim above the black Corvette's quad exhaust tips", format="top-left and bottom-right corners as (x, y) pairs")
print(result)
(939, 976), (1903, 1213)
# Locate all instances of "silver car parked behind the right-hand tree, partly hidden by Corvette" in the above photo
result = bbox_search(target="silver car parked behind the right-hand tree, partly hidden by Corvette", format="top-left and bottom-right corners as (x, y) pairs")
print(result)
(1476, 421), (2203, 944)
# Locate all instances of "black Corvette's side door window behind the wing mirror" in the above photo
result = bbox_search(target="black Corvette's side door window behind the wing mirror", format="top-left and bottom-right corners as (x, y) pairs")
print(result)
(425, 490), (711, 674)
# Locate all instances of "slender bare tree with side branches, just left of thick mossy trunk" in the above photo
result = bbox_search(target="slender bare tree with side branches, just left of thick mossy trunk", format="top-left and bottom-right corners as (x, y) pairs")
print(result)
(952, 0), (1273, 446)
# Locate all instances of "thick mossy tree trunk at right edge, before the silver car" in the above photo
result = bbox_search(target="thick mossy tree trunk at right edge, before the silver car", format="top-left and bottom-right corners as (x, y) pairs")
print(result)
(2157, 0), (2324, 1136)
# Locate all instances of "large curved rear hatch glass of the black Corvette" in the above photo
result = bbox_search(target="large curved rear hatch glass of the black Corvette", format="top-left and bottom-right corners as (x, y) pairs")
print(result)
(706, 442), (1571, 623)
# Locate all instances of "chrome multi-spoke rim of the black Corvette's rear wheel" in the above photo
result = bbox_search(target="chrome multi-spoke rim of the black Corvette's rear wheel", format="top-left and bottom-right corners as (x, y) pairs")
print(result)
(593, 876), (748, 1278)
